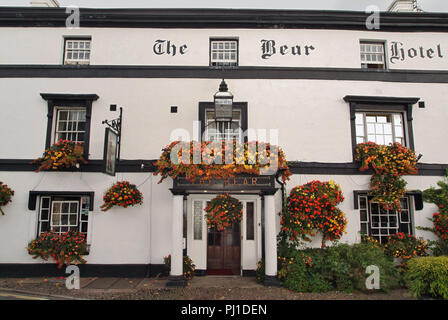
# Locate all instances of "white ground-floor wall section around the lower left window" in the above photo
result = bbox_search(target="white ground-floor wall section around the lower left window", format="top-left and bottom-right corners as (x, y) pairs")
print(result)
(0, 172), (152, 264)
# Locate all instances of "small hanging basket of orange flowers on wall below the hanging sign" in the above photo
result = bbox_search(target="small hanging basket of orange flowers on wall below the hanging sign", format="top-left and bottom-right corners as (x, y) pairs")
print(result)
(100, 181), (143, 211)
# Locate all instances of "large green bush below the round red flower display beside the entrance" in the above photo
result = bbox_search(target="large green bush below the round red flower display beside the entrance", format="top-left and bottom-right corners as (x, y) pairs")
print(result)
(279, 243), (399, 292)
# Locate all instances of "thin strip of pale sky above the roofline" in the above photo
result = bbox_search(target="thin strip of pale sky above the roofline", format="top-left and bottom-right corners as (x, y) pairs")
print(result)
(0, 0), (448, 12)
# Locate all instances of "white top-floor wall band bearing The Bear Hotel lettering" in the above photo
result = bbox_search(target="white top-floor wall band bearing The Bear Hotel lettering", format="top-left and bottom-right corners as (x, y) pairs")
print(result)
(0, 26), (448, 70)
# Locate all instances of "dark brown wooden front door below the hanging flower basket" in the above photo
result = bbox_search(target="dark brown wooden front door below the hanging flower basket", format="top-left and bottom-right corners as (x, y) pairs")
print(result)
(207, 223), (241, 275)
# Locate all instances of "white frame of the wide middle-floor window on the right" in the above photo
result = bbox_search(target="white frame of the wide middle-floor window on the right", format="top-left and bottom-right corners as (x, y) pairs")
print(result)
(355, 111), (408, 146)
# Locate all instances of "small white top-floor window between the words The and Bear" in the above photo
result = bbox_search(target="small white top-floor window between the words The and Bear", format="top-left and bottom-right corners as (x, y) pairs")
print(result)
(210, 39), (239, 67)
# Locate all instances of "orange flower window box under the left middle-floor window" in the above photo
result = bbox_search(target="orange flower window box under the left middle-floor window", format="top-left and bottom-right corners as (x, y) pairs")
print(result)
(32, 139), (87, 172)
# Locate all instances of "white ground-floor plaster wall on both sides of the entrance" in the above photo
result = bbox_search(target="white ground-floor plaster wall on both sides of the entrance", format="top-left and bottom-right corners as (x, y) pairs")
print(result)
(0, 172), (441, 264)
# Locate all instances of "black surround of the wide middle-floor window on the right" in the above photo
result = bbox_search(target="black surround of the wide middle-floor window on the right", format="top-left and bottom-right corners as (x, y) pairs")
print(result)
(344, 95), (420, 160)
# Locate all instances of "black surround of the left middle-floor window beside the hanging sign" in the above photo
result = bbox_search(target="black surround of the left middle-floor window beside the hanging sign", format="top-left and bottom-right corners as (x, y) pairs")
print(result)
(40, 93), (99, 159)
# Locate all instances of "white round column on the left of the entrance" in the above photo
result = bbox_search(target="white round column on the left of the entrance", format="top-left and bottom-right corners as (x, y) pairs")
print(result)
(170, 195), (184, 276)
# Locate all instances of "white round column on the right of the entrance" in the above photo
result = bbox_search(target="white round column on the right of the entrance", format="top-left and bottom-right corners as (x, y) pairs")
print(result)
(264, 195), (277, 277)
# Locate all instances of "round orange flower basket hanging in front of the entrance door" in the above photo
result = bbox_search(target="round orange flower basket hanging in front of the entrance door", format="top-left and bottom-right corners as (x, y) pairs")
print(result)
(205, 193), (243, 231)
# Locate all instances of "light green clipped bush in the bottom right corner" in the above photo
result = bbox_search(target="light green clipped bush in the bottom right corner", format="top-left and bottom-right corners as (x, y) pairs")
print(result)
(405, 256), (448, 299)
